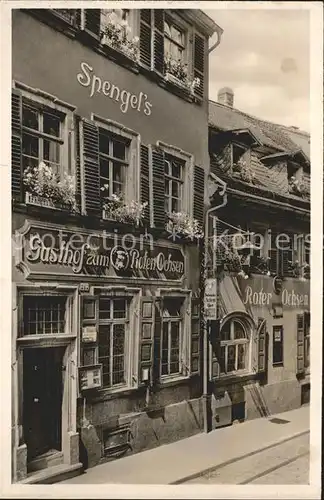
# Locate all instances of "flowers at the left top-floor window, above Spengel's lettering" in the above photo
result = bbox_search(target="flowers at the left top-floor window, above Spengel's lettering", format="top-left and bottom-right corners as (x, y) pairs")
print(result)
(101, 10), (139, 62)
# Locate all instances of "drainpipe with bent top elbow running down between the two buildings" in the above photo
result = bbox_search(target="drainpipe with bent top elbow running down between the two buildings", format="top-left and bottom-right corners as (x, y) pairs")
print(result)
(202, 189), (227, 433)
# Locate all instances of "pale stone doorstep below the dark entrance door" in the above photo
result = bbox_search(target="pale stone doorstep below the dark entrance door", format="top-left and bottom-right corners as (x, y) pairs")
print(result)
(17, 462), (83, 484)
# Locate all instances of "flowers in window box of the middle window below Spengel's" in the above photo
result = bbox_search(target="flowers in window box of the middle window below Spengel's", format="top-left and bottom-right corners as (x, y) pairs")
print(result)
(101, 188), (148, 226)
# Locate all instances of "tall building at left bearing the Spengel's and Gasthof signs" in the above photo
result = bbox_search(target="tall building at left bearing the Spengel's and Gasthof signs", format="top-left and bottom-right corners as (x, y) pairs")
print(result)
(12, 9), (221, 481)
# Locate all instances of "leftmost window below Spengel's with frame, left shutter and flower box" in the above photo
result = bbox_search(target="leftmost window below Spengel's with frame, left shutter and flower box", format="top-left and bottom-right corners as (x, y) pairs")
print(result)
(12, 82), (76, 208)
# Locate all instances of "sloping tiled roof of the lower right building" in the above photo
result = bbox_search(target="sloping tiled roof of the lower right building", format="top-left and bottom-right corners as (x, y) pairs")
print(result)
(209, 100), (306, 153)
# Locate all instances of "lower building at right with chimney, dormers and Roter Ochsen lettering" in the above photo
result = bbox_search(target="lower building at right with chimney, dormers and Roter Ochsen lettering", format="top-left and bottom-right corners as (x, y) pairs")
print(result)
(208, 88), (310, 427)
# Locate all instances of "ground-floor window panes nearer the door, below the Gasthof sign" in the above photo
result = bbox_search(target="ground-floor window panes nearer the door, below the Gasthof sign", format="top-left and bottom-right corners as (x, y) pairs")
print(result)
(99, 298), (129, 387)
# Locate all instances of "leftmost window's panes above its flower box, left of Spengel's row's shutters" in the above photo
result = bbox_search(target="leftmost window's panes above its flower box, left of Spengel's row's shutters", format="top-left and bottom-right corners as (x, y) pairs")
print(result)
(22, 100), (64, 175)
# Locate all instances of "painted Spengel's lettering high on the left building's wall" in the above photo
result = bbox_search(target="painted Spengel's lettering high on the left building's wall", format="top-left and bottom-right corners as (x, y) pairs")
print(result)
(77, 62), (152, 116)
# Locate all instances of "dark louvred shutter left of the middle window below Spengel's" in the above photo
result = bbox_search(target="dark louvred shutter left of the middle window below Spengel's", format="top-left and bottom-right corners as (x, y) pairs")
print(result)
(80, 119), (101, 216)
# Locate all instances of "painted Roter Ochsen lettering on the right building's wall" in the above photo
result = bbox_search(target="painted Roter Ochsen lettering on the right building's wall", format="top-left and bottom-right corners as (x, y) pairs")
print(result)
(238, 277), (310, 309)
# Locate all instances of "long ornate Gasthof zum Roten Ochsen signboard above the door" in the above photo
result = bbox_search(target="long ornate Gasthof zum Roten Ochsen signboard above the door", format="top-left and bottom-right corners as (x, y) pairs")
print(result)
(16, 223), (185, 280)
